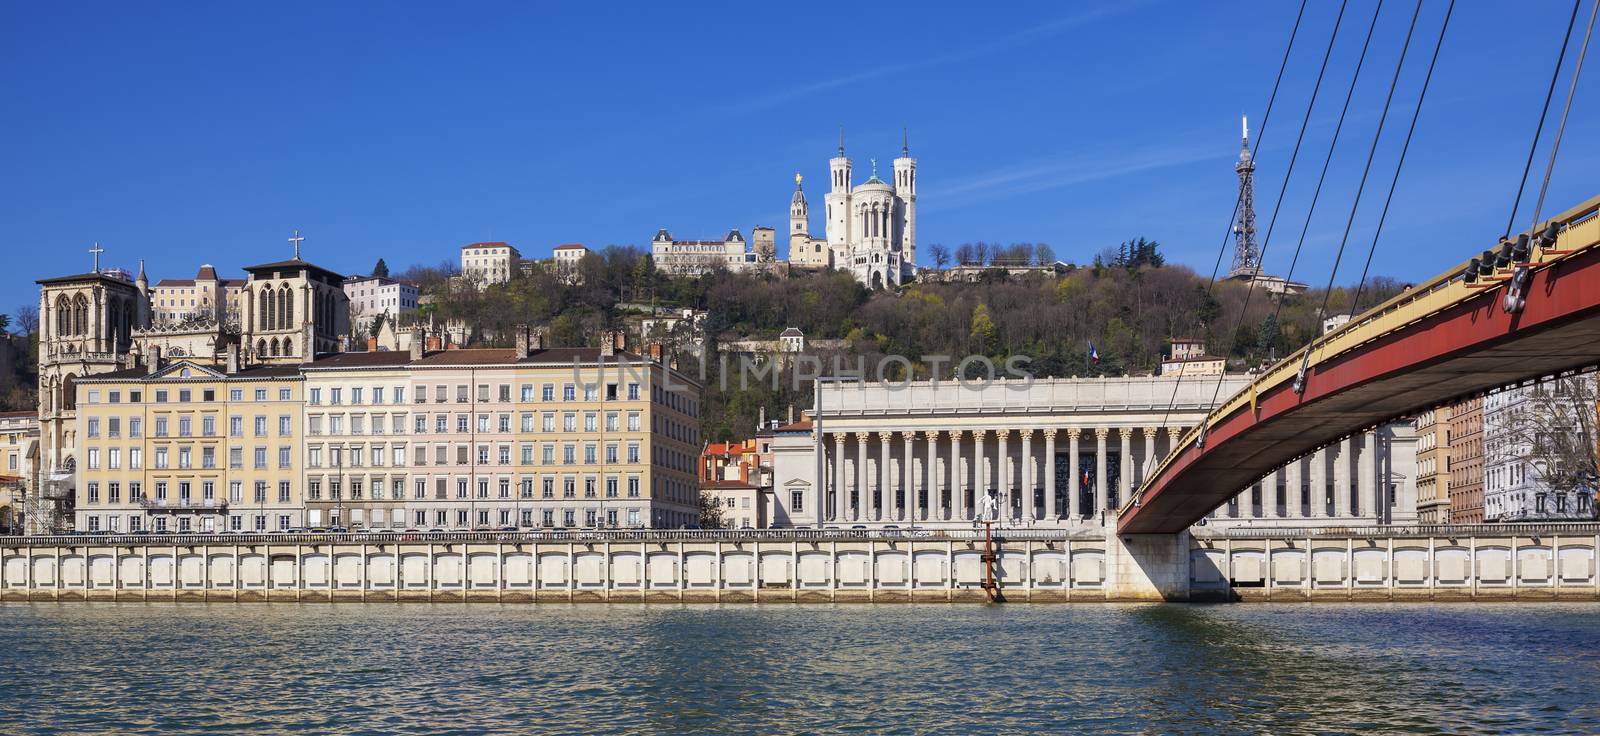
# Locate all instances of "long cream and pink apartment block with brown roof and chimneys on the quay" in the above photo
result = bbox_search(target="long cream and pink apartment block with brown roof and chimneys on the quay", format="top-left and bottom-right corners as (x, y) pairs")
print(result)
(304, 328), (699, 530)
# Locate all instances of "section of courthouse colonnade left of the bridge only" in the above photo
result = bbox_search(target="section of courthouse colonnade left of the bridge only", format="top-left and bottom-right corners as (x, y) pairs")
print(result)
(816, 426), (1187, 523)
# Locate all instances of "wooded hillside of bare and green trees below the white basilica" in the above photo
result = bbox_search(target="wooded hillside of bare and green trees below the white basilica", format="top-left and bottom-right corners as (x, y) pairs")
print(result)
(406, 238), (1403, 442)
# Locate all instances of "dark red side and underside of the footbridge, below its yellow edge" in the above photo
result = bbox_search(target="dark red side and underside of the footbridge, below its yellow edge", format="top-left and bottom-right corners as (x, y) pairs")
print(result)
(1120, 244), (1600, 533)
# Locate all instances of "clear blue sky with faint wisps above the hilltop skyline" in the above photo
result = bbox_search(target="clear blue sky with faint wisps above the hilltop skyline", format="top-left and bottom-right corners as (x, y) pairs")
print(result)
(0, 0), (1600, 312)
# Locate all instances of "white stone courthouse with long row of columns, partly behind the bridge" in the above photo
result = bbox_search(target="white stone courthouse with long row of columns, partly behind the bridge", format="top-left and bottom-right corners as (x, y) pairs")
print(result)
(768, 374), (1416, 528)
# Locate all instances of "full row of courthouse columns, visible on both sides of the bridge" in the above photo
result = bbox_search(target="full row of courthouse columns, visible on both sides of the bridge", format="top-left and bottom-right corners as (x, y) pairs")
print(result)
(814, 426), (1414, 525)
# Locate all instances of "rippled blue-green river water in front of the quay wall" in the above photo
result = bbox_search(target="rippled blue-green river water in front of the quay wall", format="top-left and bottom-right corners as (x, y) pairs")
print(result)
(0, 603), (1600, 734)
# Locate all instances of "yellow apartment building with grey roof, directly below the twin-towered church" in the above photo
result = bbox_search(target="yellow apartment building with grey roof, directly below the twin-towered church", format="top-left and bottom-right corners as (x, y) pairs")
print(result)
(74, 360), (304, 533)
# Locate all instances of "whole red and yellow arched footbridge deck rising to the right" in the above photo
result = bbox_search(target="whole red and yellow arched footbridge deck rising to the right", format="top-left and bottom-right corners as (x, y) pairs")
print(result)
(1117, 197), (1600, 534)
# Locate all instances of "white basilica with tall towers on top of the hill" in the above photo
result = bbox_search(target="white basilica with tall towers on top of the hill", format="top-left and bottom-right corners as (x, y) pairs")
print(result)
(789, 134), (917, 290)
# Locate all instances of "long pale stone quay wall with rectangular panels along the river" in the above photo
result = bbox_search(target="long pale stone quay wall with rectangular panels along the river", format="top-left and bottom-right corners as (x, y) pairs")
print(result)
(0, 525), (1600, 602)
